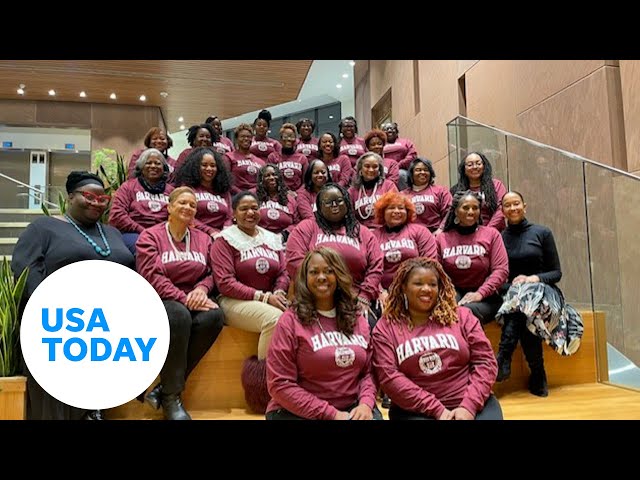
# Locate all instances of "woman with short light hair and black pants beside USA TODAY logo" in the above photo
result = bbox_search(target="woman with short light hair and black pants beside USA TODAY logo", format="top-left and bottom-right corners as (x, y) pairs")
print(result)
(136, 187), (224, 420)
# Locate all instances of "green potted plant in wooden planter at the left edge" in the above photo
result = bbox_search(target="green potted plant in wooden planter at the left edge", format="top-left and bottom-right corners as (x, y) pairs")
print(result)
(0, 258), (28, 420)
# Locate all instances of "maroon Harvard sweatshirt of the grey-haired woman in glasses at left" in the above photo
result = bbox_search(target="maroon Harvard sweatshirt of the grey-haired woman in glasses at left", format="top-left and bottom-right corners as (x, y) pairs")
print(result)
(109, 178), (175, 233)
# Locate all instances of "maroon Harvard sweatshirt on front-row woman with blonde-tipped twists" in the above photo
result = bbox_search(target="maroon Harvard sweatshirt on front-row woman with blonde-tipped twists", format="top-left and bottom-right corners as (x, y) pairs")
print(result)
(372, 307), (498, 418)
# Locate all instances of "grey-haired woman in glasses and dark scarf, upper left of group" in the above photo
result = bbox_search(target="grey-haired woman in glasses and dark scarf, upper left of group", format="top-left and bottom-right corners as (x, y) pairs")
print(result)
(109, 148), (174, 255)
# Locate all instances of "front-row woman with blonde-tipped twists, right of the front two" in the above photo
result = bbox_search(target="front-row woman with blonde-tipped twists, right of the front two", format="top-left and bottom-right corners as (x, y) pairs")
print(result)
(373, 258), (502, 420)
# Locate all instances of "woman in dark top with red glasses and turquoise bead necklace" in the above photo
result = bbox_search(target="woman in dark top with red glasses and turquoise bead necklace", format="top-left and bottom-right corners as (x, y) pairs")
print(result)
(11, 171), (135, 420)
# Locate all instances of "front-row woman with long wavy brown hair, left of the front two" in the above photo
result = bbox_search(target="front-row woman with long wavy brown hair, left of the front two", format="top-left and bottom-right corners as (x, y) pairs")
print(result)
(267, 247), (382, 420)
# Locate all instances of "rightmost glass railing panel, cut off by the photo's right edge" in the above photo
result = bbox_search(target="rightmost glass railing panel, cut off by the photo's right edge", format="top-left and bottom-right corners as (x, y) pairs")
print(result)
(585, 164), (640, 388)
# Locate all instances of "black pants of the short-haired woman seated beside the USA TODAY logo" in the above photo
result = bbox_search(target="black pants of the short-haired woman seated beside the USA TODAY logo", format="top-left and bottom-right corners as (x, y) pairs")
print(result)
(160, 300), (224, 395)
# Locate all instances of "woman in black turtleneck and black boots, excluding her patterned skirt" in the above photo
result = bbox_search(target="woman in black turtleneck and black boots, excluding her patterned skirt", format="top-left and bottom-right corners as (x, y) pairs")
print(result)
(497, 191), (562, 397)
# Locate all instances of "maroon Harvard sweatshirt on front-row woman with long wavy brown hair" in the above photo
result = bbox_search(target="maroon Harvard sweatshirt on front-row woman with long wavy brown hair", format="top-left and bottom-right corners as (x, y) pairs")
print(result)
(267, 310), (376, 420)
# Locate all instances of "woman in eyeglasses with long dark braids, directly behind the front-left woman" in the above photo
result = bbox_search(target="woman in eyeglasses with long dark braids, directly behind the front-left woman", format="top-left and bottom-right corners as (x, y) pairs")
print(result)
(286, 183), (383, 325)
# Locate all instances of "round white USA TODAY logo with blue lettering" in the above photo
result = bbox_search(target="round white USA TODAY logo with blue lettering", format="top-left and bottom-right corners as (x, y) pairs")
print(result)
(20, 260), (169, 410)
